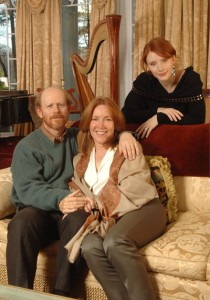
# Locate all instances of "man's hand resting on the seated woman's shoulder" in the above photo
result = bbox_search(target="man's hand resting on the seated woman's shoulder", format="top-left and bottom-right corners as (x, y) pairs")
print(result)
(119, 131), (140, 160)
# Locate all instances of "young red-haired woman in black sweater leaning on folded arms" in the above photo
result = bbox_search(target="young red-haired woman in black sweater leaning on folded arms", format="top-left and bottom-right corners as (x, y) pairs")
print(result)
(122, 38), (205, 138)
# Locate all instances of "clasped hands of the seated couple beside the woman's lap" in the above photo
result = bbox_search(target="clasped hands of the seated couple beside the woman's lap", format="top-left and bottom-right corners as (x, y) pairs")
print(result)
(59, 190), (95, 215)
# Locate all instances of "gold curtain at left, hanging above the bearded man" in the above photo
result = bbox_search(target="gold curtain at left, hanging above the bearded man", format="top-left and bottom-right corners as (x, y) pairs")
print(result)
(15, 0), (63, 135)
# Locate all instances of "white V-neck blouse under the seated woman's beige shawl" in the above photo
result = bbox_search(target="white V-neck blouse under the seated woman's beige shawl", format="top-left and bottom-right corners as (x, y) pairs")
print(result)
(84, 148), (116, 195)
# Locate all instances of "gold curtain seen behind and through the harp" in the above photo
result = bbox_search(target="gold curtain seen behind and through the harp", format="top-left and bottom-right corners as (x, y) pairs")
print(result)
(88, 0), (116, 96)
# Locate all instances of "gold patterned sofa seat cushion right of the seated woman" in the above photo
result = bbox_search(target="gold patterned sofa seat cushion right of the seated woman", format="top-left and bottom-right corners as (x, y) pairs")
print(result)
(140, 211), (210, 281)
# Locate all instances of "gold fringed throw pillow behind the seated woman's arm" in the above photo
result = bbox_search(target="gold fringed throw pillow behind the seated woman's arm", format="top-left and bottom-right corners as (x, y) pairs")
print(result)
(145, 155), (177, 223)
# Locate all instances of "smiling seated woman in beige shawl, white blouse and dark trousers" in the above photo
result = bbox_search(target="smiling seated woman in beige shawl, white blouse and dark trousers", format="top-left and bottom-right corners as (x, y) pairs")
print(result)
(66, 97), (166, 300)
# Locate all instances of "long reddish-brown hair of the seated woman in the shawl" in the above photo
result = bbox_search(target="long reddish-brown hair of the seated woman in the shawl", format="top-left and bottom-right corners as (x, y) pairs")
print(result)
(77, 97), (125, 156)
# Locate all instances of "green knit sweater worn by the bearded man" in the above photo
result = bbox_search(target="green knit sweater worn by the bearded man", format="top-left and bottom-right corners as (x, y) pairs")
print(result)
(11, 128), (78, 211)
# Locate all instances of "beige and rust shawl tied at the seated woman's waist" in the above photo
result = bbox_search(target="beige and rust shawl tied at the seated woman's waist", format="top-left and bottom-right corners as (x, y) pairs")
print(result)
(65, 146), (158, 263)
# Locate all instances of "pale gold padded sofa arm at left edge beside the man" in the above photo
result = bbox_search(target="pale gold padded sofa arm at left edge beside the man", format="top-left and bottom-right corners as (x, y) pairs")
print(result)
(0, 168), (15, 219)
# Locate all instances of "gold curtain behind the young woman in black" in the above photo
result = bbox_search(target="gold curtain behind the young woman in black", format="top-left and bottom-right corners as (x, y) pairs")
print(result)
(134, 0), (210, 88)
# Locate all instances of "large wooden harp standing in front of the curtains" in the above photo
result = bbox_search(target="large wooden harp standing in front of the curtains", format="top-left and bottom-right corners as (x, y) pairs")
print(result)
(70, 15), (121, 111)
